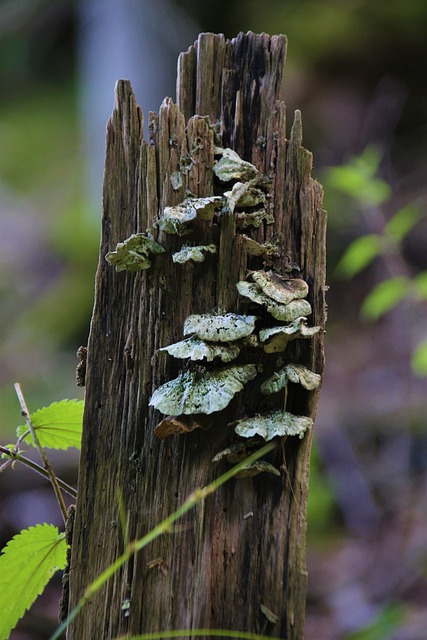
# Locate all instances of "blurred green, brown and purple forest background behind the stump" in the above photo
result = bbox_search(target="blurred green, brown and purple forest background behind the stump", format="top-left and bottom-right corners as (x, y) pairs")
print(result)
(0, 0), (427, 640)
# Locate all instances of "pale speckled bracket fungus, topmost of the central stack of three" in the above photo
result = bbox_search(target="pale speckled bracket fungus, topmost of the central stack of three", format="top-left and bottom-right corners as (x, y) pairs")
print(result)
(184, 313), (257, 342)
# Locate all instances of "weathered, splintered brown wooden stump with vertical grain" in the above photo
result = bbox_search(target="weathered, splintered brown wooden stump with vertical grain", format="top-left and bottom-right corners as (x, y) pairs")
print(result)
(67, 33), (326, 640)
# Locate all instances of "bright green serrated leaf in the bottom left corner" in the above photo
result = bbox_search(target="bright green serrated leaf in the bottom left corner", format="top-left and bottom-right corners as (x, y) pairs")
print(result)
(0, 524), (67, 640)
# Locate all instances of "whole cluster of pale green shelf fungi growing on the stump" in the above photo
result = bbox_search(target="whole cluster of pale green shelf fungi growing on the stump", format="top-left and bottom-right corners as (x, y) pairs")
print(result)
(106, 142), (321, 477)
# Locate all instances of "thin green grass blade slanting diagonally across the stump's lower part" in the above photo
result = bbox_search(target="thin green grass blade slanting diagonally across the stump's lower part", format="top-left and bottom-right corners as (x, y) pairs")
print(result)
(50, 443), (276, 640)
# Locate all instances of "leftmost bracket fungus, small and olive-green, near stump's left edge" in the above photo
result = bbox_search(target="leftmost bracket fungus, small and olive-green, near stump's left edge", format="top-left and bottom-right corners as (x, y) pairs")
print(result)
(105, 233), (165, 271)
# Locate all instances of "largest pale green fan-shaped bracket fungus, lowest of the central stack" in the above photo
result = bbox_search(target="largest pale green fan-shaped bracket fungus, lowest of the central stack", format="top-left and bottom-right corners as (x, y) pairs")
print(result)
(150, 364), (257, 416)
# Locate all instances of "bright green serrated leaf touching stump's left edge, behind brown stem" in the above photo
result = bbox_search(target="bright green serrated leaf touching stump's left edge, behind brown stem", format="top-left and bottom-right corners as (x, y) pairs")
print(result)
(16, 400), (83, 449)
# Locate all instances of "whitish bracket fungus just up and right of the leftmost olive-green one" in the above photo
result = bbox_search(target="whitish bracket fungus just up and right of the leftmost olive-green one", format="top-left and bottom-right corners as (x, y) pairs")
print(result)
(156, 196), (224, 236)
